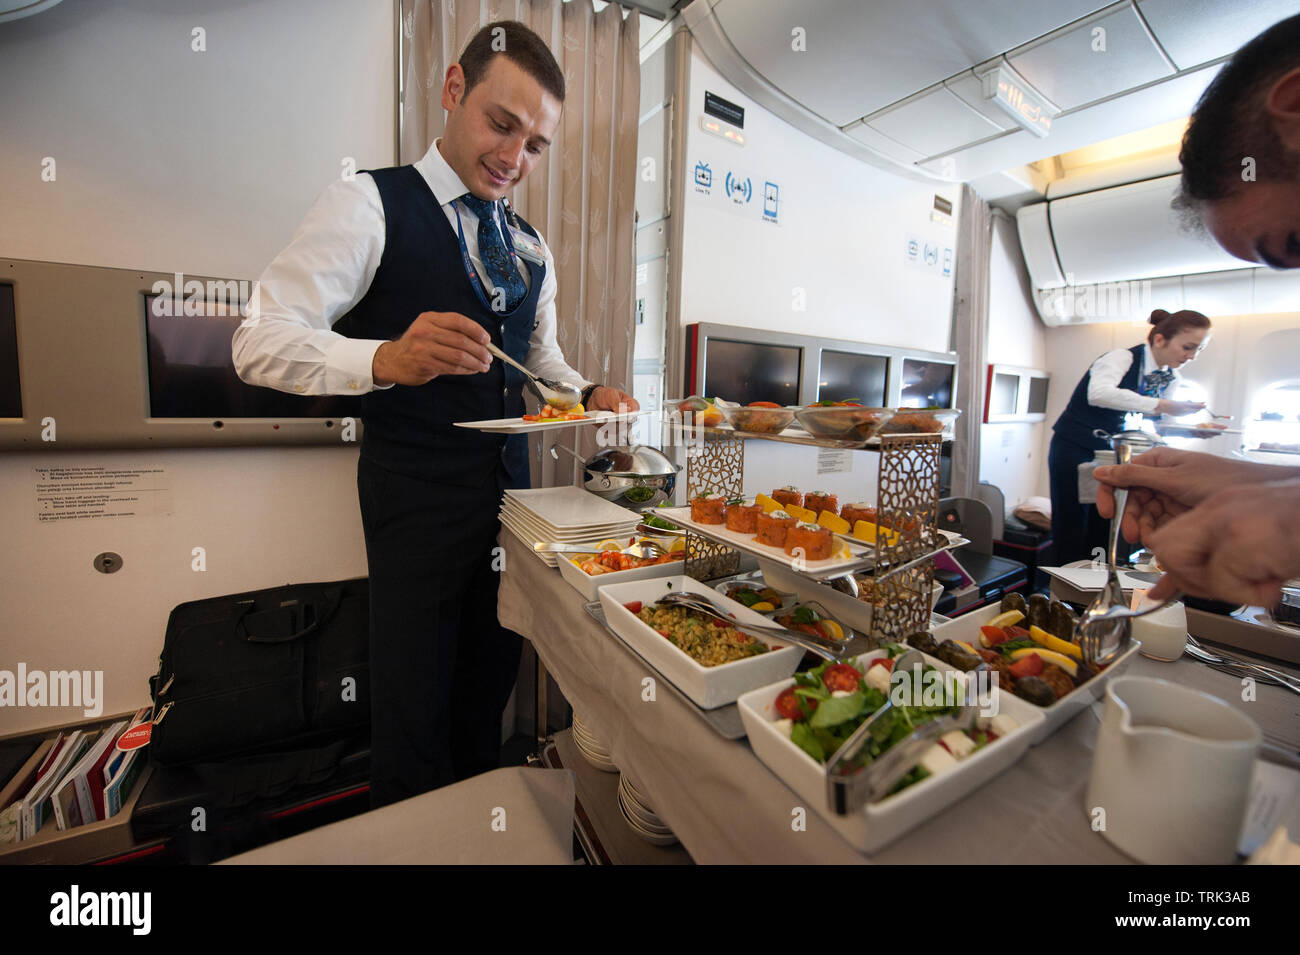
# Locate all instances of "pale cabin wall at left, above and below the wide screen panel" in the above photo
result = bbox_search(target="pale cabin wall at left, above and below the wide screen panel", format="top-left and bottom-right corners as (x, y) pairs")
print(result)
(0, 0), (394, 735)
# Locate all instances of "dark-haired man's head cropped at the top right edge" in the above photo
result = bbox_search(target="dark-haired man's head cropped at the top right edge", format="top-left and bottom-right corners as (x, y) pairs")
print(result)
(1175, 14), (1300, 269)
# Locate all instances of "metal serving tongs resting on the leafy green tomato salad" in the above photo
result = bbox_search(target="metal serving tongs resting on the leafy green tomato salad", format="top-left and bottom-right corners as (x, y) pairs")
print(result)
(826, 650), (976, 816)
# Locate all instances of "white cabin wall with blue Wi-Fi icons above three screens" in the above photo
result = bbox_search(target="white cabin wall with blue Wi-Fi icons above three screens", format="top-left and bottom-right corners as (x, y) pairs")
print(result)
(666, 46), (961, 500)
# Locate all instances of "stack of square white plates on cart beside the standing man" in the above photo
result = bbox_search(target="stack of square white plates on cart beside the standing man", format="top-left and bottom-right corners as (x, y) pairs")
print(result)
(501, 487), (641, 567)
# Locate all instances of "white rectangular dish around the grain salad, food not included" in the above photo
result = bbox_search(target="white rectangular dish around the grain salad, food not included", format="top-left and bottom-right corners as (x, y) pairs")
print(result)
(598, 576), (803, 709)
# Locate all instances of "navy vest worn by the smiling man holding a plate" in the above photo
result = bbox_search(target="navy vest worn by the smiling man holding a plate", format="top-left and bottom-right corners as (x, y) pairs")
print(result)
(334, 166), (546, 487)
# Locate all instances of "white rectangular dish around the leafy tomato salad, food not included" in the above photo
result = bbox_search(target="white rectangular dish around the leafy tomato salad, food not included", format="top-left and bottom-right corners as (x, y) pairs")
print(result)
(737, 650), (1044, 852)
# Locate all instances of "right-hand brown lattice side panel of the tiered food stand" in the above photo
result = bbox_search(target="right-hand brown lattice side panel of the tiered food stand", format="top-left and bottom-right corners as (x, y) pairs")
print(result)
(870, 434), (943, 646)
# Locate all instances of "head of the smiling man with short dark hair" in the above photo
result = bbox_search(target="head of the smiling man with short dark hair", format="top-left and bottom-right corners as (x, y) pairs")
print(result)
(441, 21), (564, 200)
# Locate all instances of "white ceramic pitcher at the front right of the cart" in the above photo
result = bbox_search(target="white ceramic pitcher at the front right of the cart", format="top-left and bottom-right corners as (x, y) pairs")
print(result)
(1084, 677), (1261, 865)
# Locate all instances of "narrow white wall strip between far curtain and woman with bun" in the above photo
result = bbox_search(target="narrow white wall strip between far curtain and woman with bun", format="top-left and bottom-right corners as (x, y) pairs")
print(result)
(966, 214), (1061, 511)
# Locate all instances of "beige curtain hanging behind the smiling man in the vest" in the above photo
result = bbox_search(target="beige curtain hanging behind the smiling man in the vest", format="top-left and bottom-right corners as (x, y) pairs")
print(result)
(400, 0), (641, 487)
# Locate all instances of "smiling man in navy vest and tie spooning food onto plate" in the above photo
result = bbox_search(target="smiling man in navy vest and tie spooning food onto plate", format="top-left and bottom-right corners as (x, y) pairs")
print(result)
(233, 21), (636, 807)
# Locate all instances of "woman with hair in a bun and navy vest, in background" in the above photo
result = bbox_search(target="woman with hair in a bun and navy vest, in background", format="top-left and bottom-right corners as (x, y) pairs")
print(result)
(1048, 308), (1210, 564)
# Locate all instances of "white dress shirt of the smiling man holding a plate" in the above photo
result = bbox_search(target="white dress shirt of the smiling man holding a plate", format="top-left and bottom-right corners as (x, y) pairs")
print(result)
(231, 142), (592, 395)
